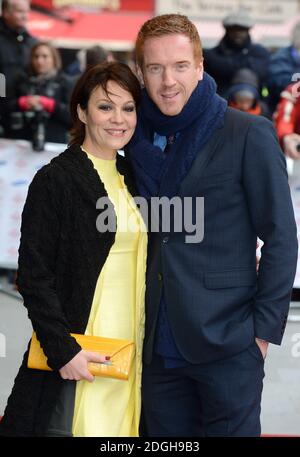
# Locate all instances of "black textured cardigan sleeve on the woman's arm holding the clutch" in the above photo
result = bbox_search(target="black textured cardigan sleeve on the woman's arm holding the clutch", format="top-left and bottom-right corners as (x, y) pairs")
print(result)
(17, 165), (81, 370)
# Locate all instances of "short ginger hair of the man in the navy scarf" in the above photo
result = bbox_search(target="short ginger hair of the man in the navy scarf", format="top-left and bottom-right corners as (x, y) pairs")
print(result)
(135, 14), (203, 68)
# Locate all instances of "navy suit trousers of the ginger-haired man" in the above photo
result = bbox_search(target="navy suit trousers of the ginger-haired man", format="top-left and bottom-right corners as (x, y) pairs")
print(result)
(142, 342), (264, 437)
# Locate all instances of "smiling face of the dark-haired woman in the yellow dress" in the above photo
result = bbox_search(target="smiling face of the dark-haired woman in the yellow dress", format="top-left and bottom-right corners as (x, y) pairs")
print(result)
(78, 81), (137, 154)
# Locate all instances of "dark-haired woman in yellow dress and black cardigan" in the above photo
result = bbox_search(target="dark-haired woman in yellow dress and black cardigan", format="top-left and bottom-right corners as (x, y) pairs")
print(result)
(0, 63), (147, 436)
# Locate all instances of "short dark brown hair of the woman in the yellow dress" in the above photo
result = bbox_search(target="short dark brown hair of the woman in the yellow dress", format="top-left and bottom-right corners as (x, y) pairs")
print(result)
(70, 62), (141, 145)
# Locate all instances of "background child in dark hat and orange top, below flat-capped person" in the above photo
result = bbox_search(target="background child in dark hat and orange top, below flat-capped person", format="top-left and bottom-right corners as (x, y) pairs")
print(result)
(227, 68), (271, 119)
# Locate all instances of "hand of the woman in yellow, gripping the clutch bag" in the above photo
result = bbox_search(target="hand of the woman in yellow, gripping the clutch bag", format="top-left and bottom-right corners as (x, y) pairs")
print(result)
(59, 349), (109, 382)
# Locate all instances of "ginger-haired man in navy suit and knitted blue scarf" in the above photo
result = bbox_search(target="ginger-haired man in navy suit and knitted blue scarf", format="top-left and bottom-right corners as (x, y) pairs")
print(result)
(127, 14), (297, 436)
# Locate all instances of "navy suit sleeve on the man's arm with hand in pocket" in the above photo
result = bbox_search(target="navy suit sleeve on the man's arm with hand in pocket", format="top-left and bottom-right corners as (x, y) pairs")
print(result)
(243, 118), (298, 344)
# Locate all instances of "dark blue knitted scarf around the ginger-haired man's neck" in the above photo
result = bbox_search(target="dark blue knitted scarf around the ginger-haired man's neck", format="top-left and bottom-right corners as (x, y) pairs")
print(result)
(127, 73), (227, 198)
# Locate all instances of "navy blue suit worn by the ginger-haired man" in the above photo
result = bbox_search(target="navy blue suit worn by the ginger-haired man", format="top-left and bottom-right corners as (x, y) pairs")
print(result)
(138, 108), (297, 436)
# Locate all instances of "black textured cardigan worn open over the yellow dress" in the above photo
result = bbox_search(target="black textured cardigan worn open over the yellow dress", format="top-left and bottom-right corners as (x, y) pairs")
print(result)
(0, 145), (135, 436)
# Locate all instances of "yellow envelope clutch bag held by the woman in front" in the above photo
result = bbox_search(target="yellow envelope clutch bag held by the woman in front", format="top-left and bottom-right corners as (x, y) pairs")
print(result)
(27, 332), (135, 380)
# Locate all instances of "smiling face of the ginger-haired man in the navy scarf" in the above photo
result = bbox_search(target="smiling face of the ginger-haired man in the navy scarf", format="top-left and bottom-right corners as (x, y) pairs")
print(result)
(141, 34), (203, 116)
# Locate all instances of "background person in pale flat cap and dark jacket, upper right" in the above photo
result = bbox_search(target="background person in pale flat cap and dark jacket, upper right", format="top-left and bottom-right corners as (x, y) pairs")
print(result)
(204, 12), (269, 96)
